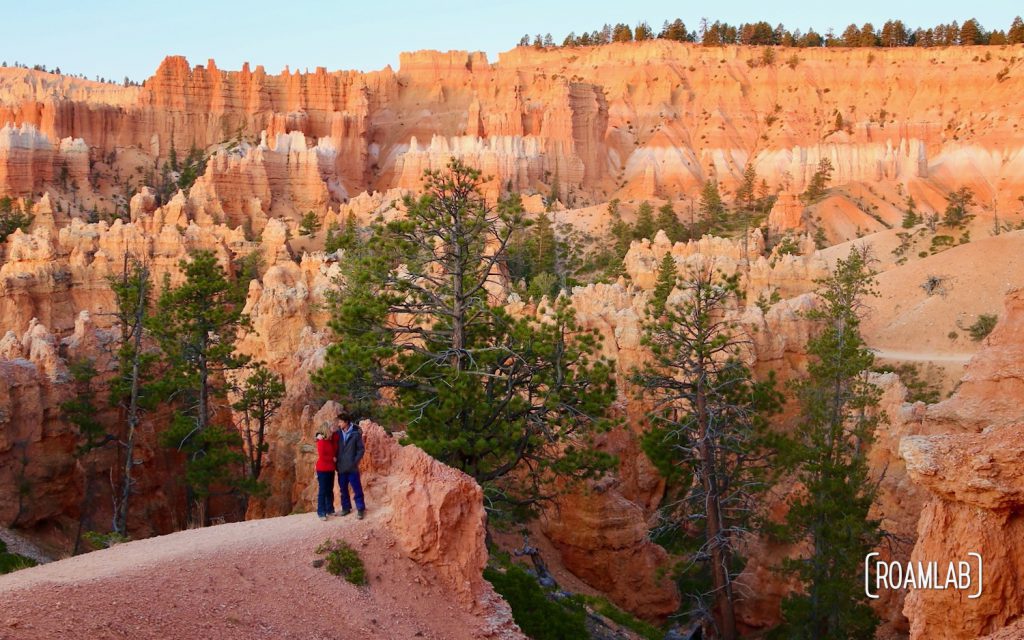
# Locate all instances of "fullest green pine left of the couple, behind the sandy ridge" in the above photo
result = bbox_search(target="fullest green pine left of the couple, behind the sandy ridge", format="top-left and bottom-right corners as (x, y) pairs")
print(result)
(148, 250), (248, 523)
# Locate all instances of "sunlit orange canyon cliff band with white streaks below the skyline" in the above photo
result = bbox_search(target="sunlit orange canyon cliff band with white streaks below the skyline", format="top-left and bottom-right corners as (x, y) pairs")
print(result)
(0, 41), (1024, 215)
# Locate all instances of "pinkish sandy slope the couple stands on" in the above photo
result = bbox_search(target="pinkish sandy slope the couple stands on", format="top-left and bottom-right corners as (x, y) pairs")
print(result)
(0, 511), (512, 640)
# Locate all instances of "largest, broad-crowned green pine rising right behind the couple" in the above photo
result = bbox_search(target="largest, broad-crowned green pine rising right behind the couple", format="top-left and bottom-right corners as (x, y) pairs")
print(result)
(314, 160), (614, 516)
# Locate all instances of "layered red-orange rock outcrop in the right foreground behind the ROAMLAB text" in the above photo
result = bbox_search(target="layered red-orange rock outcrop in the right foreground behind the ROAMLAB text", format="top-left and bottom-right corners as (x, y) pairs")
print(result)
(899, 290), (1024, 639)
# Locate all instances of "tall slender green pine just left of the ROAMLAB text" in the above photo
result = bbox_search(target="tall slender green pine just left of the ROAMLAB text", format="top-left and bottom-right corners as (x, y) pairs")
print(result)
(782, 249), (881, 639)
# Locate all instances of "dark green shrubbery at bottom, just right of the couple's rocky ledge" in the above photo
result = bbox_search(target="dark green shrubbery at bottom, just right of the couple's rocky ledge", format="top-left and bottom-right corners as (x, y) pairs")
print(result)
(483, 564), (590, 640)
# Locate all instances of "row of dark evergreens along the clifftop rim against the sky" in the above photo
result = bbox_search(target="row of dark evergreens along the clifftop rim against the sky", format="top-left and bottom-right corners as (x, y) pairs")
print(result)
(519, 16), (1024, 48)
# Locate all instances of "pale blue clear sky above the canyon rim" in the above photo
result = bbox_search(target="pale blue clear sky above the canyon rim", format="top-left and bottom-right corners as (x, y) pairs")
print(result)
(0, 0), (1024, 81)
